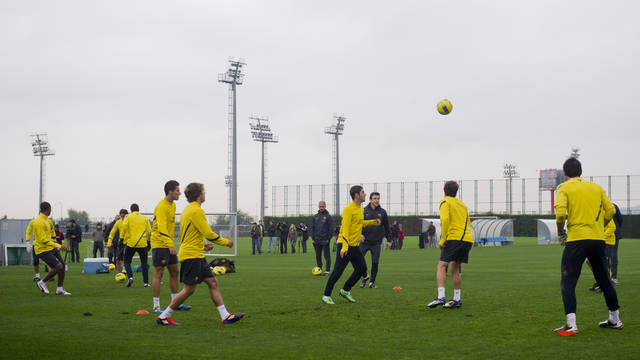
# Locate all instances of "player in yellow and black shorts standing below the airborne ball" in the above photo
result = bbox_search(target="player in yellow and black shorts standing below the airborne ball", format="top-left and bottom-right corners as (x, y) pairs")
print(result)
(427, 181), (473, 308)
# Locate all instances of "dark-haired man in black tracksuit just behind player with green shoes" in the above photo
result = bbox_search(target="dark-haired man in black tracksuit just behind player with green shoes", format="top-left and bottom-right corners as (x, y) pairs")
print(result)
(360, 192), (390, 289)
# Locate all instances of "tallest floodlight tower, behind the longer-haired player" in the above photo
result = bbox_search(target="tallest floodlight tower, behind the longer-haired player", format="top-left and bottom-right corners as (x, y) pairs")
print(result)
(218, 59), (246, 213)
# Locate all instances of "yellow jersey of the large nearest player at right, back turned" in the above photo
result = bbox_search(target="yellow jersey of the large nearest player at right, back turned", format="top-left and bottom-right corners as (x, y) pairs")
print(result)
(555, 177), (616, 242)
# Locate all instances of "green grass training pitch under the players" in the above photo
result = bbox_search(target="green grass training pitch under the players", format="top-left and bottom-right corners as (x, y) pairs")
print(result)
(0, 238), (640, 359)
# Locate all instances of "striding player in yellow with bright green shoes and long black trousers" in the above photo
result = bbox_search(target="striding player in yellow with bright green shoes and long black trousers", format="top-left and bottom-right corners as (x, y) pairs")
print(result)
(322, 185), (380, 305)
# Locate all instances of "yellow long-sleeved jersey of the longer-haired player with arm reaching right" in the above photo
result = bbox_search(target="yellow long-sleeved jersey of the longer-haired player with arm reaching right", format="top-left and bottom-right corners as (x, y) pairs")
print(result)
(178, 201), (229, 261)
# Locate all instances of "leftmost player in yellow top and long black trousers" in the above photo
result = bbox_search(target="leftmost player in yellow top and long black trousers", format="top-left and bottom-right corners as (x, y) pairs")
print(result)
(27, 201), (71, 295)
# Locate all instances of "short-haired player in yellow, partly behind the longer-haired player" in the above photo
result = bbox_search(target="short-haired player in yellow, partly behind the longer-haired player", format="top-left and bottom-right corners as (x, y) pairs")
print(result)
(151, 180), (191, 314)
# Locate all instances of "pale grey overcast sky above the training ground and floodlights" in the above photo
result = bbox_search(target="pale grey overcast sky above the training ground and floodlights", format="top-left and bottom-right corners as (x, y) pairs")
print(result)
(0, 0), (640, 218)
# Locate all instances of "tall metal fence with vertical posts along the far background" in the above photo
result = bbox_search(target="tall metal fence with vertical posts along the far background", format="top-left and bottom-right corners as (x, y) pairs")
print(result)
(265, 175), (640, 216)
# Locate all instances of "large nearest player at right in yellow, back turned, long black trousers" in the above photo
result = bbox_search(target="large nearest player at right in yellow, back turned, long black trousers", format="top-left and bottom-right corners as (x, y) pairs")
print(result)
(554, 157), (623, 336)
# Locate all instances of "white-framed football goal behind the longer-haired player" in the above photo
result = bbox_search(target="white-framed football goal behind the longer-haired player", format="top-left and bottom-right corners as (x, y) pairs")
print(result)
(142, 213), (238, 257)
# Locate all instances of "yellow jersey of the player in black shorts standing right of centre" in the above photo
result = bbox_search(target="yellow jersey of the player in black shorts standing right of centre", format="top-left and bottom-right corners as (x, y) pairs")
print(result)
(438, 196), (473, 246)
